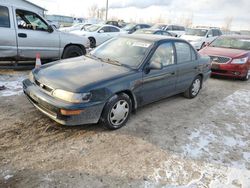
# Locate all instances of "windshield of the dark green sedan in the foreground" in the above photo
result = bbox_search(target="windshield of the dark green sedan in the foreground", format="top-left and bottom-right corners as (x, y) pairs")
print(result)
(90, 37), (152, 69)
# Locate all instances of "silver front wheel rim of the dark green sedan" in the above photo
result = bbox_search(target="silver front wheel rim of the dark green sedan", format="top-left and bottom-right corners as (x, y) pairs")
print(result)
(109, 100), (129, 126)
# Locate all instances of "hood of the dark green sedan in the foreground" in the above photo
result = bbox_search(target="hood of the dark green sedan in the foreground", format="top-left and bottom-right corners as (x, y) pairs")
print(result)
(34, 56), (132, 92)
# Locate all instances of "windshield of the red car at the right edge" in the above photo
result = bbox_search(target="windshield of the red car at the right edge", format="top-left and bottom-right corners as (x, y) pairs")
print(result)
(210, 37), (250, 50)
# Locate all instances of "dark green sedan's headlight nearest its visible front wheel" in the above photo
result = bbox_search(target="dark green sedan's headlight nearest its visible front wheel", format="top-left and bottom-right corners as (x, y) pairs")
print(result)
(52, 89), (91, 103)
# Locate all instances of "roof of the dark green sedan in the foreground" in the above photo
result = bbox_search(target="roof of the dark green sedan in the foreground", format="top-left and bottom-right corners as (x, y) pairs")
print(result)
(122, 34), (186, 42)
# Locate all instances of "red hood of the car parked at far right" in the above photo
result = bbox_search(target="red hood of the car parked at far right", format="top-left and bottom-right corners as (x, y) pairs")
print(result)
(199, 46), (248, 58)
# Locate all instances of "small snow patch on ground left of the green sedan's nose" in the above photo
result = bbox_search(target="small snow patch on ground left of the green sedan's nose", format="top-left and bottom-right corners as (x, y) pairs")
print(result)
(0, 73), (27, 97)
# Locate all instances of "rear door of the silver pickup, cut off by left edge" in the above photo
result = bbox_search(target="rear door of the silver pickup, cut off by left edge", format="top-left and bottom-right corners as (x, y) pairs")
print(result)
(0, 6), (17, 60)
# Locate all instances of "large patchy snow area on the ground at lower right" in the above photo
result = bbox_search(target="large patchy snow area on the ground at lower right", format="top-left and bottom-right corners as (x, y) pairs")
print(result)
(145, 90), (250, 188)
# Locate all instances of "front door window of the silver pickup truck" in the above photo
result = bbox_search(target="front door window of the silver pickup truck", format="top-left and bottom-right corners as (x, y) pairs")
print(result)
(16, 9), (48, 31)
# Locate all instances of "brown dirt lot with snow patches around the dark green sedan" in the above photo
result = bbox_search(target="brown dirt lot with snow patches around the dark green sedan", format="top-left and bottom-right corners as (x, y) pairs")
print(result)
(0, 71), (250, 188)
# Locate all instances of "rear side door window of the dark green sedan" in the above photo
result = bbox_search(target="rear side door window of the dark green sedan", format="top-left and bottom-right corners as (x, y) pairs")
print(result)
(175, 42), (192, 63)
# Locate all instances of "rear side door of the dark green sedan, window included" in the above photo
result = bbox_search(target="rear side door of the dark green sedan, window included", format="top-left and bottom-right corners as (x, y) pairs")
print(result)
(175, 41), (198, 92)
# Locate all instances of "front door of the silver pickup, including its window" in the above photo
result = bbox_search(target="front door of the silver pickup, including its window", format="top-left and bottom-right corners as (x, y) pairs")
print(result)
(15, 9), (60, 59)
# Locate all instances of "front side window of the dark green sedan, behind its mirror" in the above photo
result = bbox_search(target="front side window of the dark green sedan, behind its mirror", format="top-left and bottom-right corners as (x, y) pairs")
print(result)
(150, 42), (175, 67)
